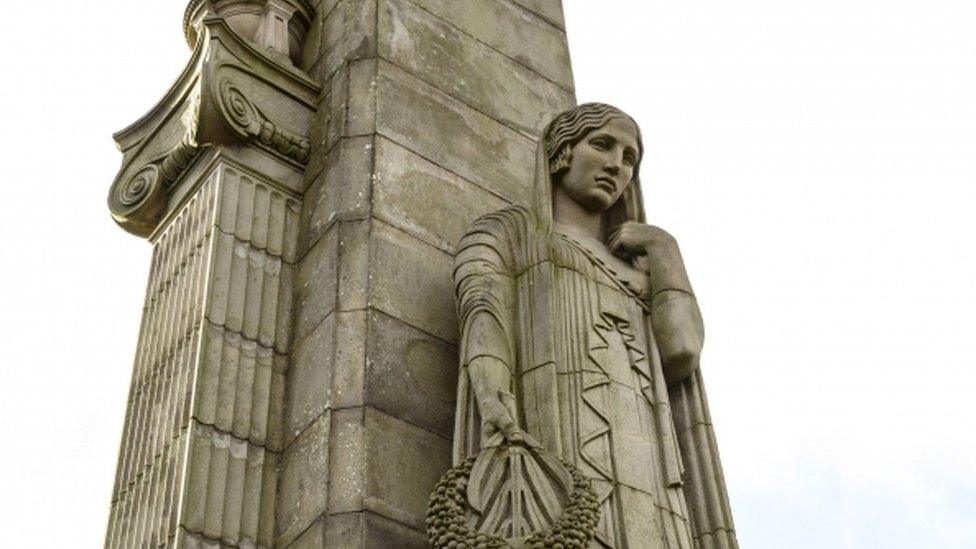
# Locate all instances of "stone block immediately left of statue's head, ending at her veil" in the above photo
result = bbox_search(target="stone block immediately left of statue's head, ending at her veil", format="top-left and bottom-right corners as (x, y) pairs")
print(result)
(376, 61), (535, 208)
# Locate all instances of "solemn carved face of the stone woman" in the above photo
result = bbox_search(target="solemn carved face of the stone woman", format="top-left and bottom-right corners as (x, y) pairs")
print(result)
(559, 118), (640, 212)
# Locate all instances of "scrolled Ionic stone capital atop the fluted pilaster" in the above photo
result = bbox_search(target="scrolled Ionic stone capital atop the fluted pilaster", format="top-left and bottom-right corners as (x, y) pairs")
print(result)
(108, 17), (320, 237)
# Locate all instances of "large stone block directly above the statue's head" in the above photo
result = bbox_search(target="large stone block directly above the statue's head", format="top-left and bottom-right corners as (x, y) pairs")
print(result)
(378, 0), (575, 136)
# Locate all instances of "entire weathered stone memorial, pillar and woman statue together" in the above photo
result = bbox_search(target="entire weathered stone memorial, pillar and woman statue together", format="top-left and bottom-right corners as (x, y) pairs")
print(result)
(105, 0), (737, 549)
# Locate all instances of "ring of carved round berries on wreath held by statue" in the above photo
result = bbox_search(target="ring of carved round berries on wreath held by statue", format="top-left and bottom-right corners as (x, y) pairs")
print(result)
(427, 457), (600, 549)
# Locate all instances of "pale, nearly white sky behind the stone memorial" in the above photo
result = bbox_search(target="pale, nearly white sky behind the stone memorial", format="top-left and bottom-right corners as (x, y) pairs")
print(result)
(0, 0), (976, 549)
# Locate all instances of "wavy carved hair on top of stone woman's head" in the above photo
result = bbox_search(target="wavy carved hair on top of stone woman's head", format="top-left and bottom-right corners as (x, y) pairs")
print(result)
(545, 103), (644, 178)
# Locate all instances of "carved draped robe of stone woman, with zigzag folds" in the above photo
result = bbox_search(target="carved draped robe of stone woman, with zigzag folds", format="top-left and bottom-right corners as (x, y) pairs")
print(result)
(454, 207), (736, 549)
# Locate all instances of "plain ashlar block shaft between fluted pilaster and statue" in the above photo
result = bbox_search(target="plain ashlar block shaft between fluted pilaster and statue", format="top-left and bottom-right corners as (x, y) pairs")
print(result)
(277, 0), (575, 547)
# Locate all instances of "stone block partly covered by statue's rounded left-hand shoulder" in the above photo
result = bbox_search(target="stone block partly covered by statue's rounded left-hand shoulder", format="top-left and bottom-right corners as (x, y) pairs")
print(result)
(373, 137), (506, 253)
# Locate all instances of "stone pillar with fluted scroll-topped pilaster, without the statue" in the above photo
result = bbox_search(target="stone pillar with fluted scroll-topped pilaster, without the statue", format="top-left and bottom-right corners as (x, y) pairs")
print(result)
(106, 0), (575, 548)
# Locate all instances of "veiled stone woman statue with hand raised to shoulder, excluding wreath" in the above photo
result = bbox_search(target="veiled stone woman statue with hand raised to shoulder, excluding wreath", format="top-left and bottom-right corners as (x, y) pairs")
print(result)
(438, 103), (736, 549)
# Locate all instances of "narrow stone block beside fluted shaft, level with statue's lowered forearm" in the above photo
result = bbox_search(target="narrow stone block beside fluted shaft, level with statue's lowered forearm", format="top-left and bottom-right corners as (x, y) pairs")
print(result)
(284, 314), (335, 446)
